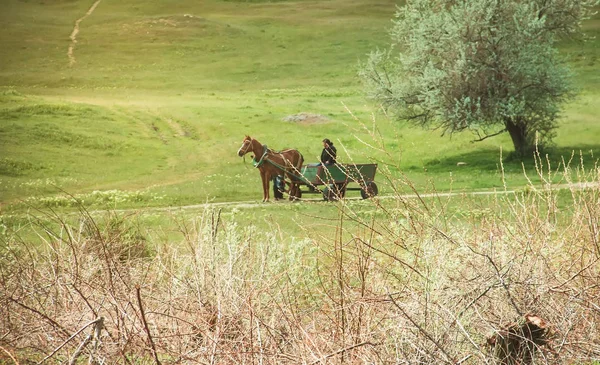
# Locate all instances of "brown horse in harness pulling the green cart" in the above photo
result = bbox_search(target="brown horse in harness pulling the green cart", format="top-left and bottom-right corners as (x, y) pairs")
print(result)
(238, 136), (304, 202)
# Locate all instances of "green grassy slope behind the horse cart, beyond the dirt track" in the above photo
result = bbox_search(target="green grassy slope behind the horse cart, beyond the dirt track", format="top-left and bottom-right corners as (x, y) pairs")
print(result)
(0, 0), (600, 211)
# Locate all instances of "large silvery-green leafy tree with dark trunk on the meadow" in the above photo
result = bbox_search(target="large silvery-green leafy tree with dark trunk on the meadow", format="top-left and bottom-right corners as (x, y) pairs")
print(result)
(360, 0), (598, 155)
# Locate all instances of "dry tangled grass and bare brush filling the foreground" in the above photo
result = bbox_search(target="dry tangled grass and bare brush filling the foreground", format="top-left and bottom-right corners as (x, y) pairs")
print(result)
(0, 155), (600, 364)
